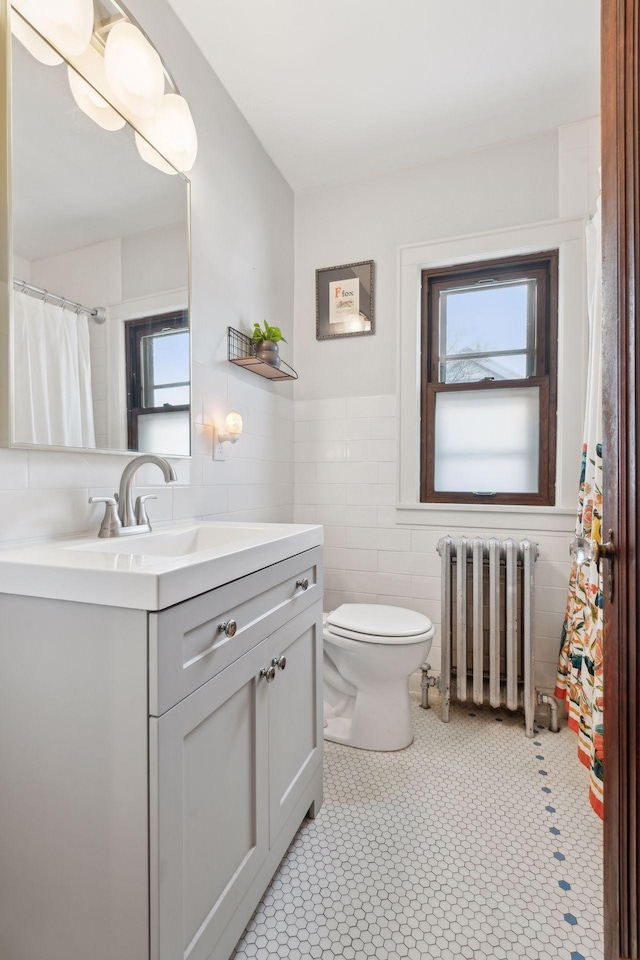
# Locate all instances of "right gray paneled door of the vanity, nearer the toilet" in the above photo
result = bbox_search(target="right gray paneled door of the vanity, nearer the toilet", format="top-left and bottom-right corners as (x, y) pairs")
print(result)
(269, 603), (324, 844)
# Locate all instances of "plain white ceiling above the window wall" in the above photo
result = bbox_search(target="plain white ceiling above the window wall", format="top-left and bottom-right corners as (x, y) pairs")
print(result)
(169, 0), (600, 191)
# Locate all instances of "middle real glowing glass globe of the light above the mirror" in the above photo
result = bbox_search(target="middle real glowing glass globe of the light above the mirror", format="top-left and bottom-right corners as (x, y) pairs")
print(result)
(104, 23), (164, 120)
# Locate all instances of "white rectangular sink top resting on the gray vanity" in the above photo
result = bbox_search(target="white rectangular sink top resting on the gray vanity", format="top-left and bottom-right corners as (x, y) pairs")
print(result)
(0, 521), (322, 610)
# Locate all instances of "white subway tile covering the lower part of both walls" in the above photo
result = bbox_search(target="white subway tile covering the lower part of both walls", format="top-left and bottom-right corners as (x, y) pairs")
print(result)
(0, 380), (570, 689)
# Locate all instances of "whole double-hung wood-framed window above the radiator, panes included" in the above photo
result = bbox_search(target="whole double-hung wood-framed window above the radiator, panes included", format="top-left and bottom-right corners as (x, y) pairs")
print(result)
(421, 251), (558, 506)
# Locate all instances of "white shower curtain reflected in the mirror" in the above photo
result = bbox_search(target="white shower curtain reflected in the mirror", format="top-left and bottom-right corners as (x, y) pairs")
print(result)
(13, 293), (96, 447)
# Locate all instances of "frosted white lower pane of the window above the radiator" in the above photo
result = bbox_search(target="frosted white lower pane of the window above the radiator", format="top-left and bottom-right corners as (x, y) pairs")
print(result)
(434, 387), (540, 493)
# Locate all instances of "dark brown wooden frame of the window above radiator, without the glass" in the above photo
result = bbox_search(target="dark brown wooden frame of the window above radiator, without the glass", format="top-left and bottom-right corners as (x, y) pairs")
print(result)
(420, 250), (558, 507)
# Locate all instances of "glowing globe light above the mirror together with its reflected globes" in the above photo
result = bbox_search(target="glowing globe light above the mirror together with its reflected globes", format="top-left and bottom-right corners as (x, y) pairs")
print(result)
(11, 0), (198, 174)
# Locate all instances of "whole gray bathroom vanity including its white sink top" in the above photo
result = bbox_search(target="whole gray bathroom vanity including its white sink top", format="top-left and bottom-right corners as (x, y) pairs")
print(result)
(0, 523), (323, 960)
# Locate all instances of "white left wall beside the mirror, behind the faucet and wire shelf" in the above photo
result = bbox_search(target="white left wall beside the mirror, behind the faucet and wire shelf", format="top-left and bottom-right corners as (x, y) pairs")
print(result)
(0, 0), (293, 543)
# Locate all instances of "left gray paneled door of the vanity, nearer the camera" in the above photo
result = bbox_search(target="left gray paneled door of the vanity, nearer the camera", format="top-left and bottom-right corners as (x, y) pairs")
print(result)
(149, 641), (270, 960)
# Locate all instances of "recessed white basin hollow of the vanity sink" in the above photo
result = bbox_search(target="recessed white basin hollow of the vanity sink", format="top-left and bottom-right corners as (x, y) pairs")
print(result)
(64, 523), (278, 557)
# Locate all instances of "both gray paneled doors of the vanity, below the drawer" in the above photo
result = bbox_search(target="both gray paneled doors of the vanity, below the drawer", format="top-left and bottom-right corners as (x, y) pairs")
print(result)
(149, 602), (322, 960)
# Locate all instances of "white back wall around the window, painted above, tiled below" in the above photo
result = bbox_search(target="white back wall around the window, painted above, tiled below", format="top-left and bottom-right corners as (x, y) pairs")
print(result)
(294, 121), (599, 688)
